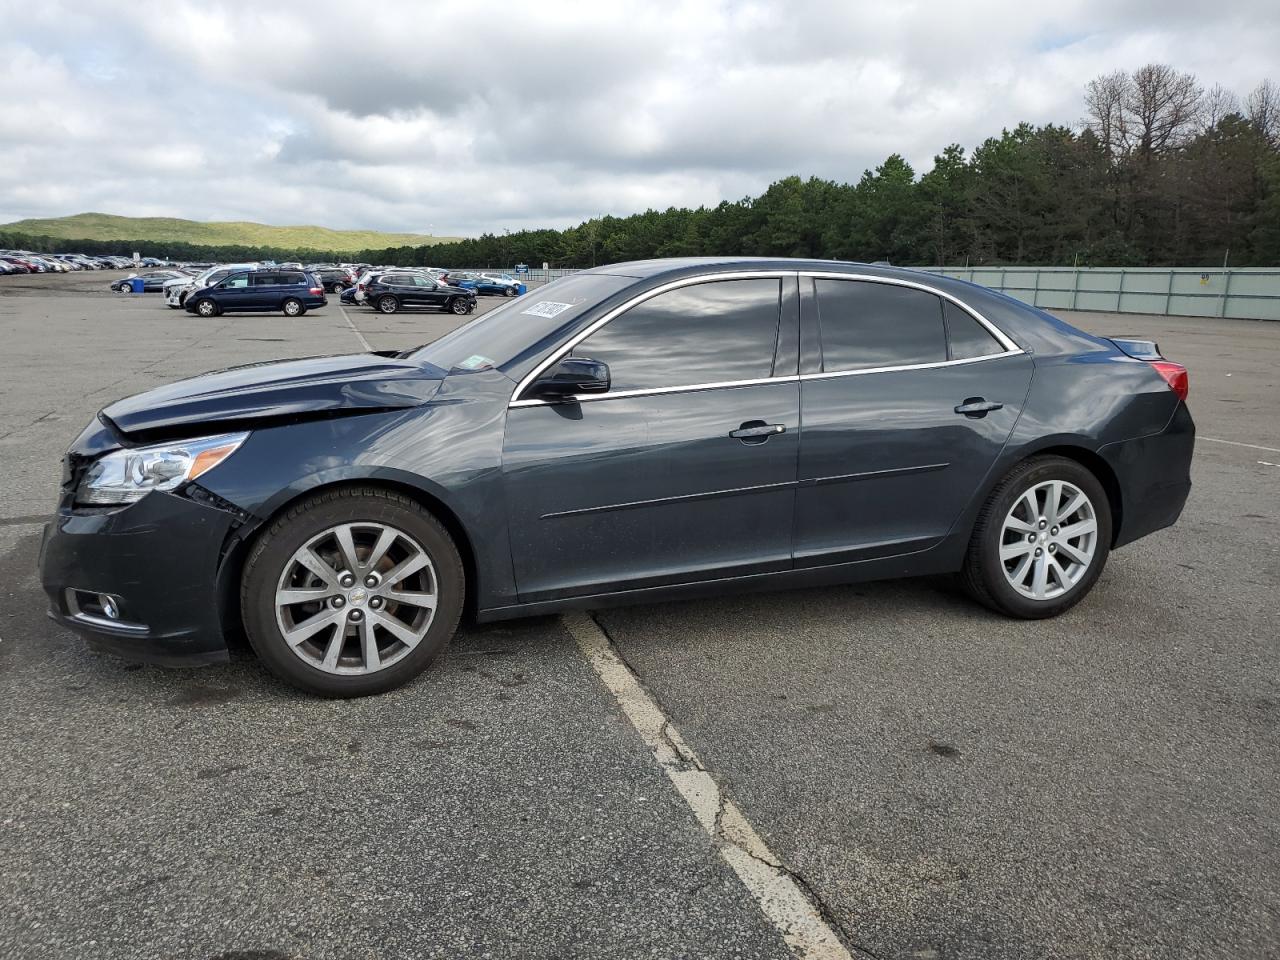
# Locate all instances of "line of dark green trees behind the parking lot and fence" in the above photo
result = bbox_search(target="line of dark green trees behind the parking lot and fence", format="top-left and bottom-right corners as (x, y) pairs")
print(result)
(0, 64), (1280, 268)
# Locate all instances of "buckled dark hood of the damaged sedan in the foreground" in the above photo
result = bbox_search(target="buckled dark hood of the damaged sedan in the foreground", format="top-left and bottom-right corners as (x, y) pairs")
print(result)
(102, 353), (445, 439)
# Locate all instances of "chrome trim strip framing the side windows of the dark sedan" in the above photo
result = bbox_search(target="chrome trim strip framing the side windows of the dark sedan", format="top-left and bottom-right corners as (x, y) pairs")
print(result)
(507, 270), (1027, 410)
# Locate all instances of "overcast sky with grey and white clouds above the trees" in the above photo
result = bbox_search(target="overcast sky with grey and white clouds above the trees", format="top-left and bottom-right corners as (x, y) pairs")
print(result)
(0, 0), (1280, 236)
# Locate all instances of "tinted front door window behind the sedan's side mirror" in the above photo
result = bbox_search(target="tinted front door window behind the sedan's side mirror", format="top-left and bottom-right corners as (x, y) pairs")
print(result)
(573, 276), (782, 390)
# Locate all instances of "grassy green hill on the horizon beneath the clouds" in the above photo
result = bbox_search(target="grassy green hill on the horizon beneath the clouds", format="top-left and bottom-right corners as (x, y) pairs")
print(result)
(0, 214), (457, 251)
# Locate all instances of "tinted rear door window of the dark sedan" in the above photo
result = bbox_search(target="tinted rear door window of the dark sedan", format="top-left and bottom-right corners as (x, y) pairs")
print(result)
(814, 279), (947, 372)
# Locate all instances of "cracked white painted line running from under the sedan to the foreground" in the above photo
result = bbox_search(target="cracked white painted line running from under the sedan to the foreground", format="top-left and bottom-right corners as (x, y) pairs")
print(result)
(563, 613), (852, 960)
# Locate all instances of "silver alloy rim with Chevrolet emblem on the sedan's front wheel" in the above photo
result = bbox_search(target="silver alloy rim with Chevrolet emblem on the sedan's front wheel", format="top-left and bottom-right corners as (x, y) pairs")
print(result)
(275, 521), (439, 676)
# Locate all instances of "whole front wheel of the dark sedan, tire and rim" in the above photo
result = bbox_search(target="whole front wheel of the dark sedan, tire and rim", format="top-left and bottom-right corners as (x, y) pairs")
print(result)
(241, 486), (466, 698)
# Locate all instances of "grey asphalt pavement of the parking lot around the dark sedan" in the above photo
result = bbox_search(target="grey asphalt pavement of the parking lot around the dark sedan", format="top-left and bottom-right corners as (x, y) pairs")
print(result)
(0, 273), (1280, 960)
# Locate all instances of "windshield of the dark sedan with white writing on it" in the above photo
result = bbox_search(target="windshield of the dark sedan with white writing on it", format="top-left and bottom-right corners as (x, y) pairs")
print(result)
(411, 274), (635, 371)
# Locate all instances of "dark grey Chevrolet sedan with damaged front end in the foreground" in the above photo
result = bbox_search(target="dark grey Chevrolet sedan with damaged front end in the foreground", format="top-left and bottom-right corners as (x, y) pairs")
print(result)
(41, 260), (1194, 696)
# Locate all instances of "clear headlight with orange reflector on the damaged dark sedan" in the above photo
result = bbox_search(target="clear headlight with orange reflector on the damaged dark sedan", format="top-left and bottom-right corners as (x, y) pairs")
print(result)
(76, 433), (248, 507)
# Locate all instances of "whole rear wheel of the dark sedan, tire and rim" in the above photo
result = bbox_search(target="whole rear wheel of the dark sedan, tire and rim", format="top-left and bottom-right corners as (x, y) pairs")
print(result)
(960, 456), (1111, 620)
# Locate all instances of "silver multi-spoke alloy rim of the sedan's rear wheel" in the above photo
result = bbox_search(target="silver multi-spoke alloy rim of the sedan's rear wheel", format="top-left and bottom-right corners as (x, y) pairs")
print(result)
(1000, 480), (1098, 600)
